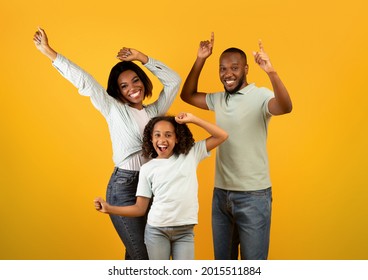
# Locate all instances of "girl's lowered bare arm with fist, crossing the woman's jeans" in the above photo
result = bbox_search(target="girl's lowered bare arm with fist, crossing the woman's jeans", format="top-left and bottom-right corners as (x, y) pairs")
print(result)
(93, 196), (150, 217)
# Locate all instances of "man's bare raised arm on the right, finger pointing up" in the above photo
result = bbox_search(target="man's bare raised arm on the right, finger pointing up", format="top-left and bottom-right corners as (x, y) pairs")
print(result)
(253, 40), (293, 115)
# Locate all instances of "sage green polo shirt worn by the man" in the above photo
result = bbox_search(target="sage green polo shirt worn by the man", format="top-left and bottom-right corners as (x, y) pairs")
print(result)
(206, 84), (274, 191)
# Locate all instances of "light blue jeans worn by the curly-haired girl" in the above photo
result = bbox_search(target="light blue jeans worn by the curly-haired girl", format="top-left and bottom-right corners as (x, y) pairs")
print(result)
(145, 224), (194, 260)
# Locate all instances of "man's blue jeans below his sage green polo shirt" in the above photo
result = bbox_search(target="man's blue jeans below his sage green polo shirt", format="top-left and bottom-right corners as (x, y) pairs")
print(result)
(212, 188), (272, 260)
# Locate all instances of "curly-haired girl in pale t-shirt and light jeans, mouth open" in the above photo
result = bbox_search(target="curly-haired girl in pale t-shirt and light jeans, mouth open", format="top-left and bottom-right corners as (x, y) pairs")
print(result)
(94, 113), (228, 260)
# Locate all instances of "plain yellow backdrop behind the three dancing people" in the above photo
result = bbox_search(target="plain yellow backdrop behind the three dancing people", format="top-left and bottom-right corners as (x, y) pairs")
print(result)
(0, 0), (368, 259)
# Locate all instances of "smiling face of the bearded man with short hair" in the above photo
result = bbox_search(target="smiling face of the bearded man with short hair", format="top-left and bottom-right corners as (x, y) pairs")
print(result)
(219, 52), (248, 93)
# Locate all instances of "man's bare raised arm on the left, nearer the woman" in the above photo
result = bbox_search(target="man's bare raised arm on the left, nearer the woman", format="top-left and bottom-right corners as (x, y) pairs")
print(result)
(180, 32), (215, 110)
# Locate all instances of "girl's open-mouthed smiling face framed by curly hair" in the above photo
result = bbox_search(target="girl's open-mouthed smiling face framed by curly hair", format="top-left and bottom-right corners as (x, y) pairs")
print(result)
(151, 121), (178, 158)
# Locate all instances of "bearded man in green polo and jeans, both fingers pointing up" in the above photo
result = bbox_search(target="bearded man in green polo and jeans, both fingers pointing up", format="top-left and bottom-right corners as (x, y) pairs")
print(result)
(181, 33), (292, 260)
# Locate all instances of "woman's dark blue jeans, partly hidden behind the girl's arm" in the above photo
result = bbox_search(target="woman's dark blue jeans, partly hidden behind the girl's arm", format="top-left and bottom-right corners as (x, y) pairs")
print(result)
(106, 168), (148, 260)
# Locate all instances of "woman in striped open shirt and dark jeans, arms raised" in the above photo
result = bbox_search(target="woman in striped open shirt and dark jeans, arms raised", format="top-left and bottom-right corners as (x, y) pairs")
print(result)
(33, 28), (181, 260)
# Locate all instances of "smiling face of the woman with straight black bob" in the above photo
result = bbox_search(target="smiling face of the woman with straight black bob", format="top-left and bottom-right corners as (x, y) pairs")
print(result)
(118, 70), (145, 110)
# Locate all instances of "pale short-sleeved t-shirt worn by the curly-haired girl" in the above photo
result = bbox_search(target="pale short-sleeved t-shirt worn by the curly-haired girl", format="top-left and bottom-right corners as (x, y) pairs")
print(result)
(137, 140), (209, 227)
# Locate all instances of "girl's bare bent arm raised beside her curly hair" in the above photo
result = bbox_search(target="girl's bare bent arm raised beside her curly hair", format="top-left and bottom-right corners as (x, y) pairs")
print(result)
(175, 113), (229, 152)
